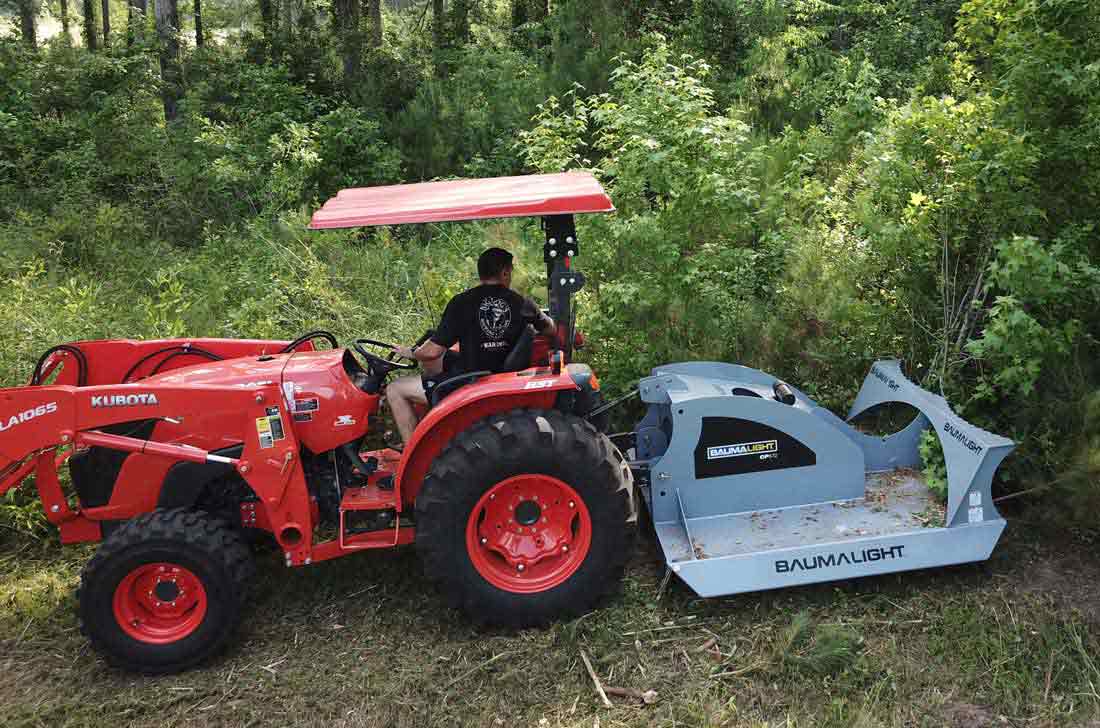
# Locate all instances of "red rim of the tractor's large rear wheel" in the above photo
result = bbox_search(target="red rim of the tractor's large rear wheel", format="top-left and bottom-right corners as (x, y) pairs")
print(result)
(466, 474), (592, 594)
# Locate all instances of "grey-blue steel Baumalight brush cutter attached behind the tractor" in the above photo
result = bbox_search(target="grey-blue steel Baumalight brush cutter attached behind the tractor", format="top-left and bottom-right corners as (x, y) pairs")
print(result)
(635, 361), (1014, 596)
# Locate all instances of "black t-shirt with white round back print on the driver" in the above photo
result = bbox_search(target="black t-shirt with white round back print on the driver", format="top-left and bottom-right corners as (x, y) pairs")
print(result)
(431, 284), (543, 375)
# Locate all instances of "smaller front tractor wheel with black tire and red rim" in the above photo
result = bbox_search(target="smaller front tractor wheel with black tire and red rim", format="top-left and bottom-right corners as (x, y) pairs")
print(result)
(77, 508), (253, 673)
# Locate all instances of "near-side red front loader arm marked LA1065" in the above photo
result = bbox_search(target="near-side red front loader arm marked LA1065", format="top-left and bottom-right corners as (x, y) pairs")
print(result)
(0, 382), (312, 563)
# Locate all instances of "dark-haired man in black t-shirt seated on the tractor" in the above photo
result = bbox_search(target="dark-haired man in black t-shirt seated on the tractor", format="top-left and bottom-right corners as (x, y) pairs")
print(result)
(386, 247), (554, 443)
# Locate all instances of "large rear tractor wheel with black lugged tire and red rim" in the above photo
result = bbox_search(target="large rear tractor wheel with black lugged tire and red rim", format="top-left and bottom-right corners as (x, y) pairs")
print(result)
(416, 410), (633, 627)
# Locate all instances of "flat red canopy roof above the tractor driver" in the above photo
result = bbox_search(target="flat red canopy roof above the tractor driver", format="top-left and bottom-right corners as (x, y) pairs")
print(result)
(309, 172), (615, 230)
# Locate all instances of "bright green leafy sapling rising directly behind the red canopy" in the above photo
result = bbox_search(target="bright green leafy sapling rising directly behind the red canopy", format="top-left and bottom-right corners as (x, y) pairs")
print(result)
(519, 36), (767, 386)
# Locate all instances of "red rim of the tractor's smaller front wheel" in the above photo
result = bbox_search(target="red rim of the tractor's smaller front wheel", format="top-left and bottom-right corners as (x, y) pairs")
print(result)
(113, 563), (207, 644)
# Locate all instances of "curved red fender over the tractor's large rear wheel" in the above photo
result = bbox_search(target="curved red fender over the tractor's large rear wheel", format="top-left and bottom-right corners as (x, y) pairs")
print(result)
(396, 368), (578, 508)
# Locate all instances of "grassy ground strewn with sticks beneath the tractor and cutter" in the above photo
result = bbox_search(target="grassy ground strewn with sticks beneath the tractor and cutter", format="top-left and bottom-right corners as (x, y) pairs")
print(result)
(0, 525), (1100, 727)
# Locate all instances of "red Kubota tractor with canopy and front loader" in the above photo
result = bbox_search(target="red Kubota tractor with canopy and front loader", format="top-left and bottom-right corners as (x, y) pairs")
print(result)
(0, 173), (635, 673)
